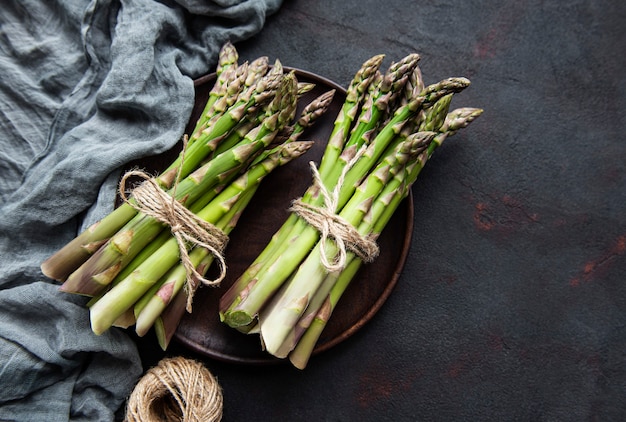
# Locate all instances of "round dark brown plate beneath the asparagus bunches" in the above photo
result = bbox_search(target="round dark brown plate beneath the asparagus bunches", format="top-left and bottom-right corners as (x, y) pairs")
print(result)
(129, 68), (413, 364)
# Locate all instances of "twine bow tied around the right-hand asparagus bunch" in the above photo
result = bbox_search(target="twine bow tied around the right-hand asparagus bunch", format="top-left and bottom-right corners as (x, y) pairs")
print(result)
(290, 147), (379, 272)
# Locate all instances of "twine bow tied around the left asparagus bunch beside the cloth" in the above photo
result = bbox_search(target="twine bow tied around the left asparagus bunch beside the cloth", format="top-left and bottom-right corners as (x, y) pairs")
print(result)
(119, 136), (228, 312)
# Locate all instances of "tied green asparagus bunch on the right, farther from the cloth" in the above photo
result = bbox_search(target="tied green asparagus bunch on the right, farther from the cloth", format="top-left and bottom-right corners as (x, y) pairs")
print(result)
(220, 54), (482, 369)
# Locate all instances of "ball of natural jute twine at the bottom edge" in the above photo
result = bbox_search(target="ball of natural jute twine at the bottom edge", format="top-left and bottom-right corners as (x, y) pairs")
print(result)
(125, 357), (224, 422)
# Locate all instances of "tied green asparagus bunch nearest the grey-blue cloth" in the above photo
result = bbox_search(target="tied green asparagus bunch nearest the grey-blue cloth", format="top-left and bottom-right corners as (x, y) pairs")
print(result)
(41, 43), (334, 349)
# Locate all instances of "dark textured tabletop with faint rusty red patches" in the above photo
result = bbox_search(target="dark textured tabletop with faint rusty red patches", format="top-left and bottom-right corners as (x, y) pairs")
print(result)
(143, 0), (626, 421)
